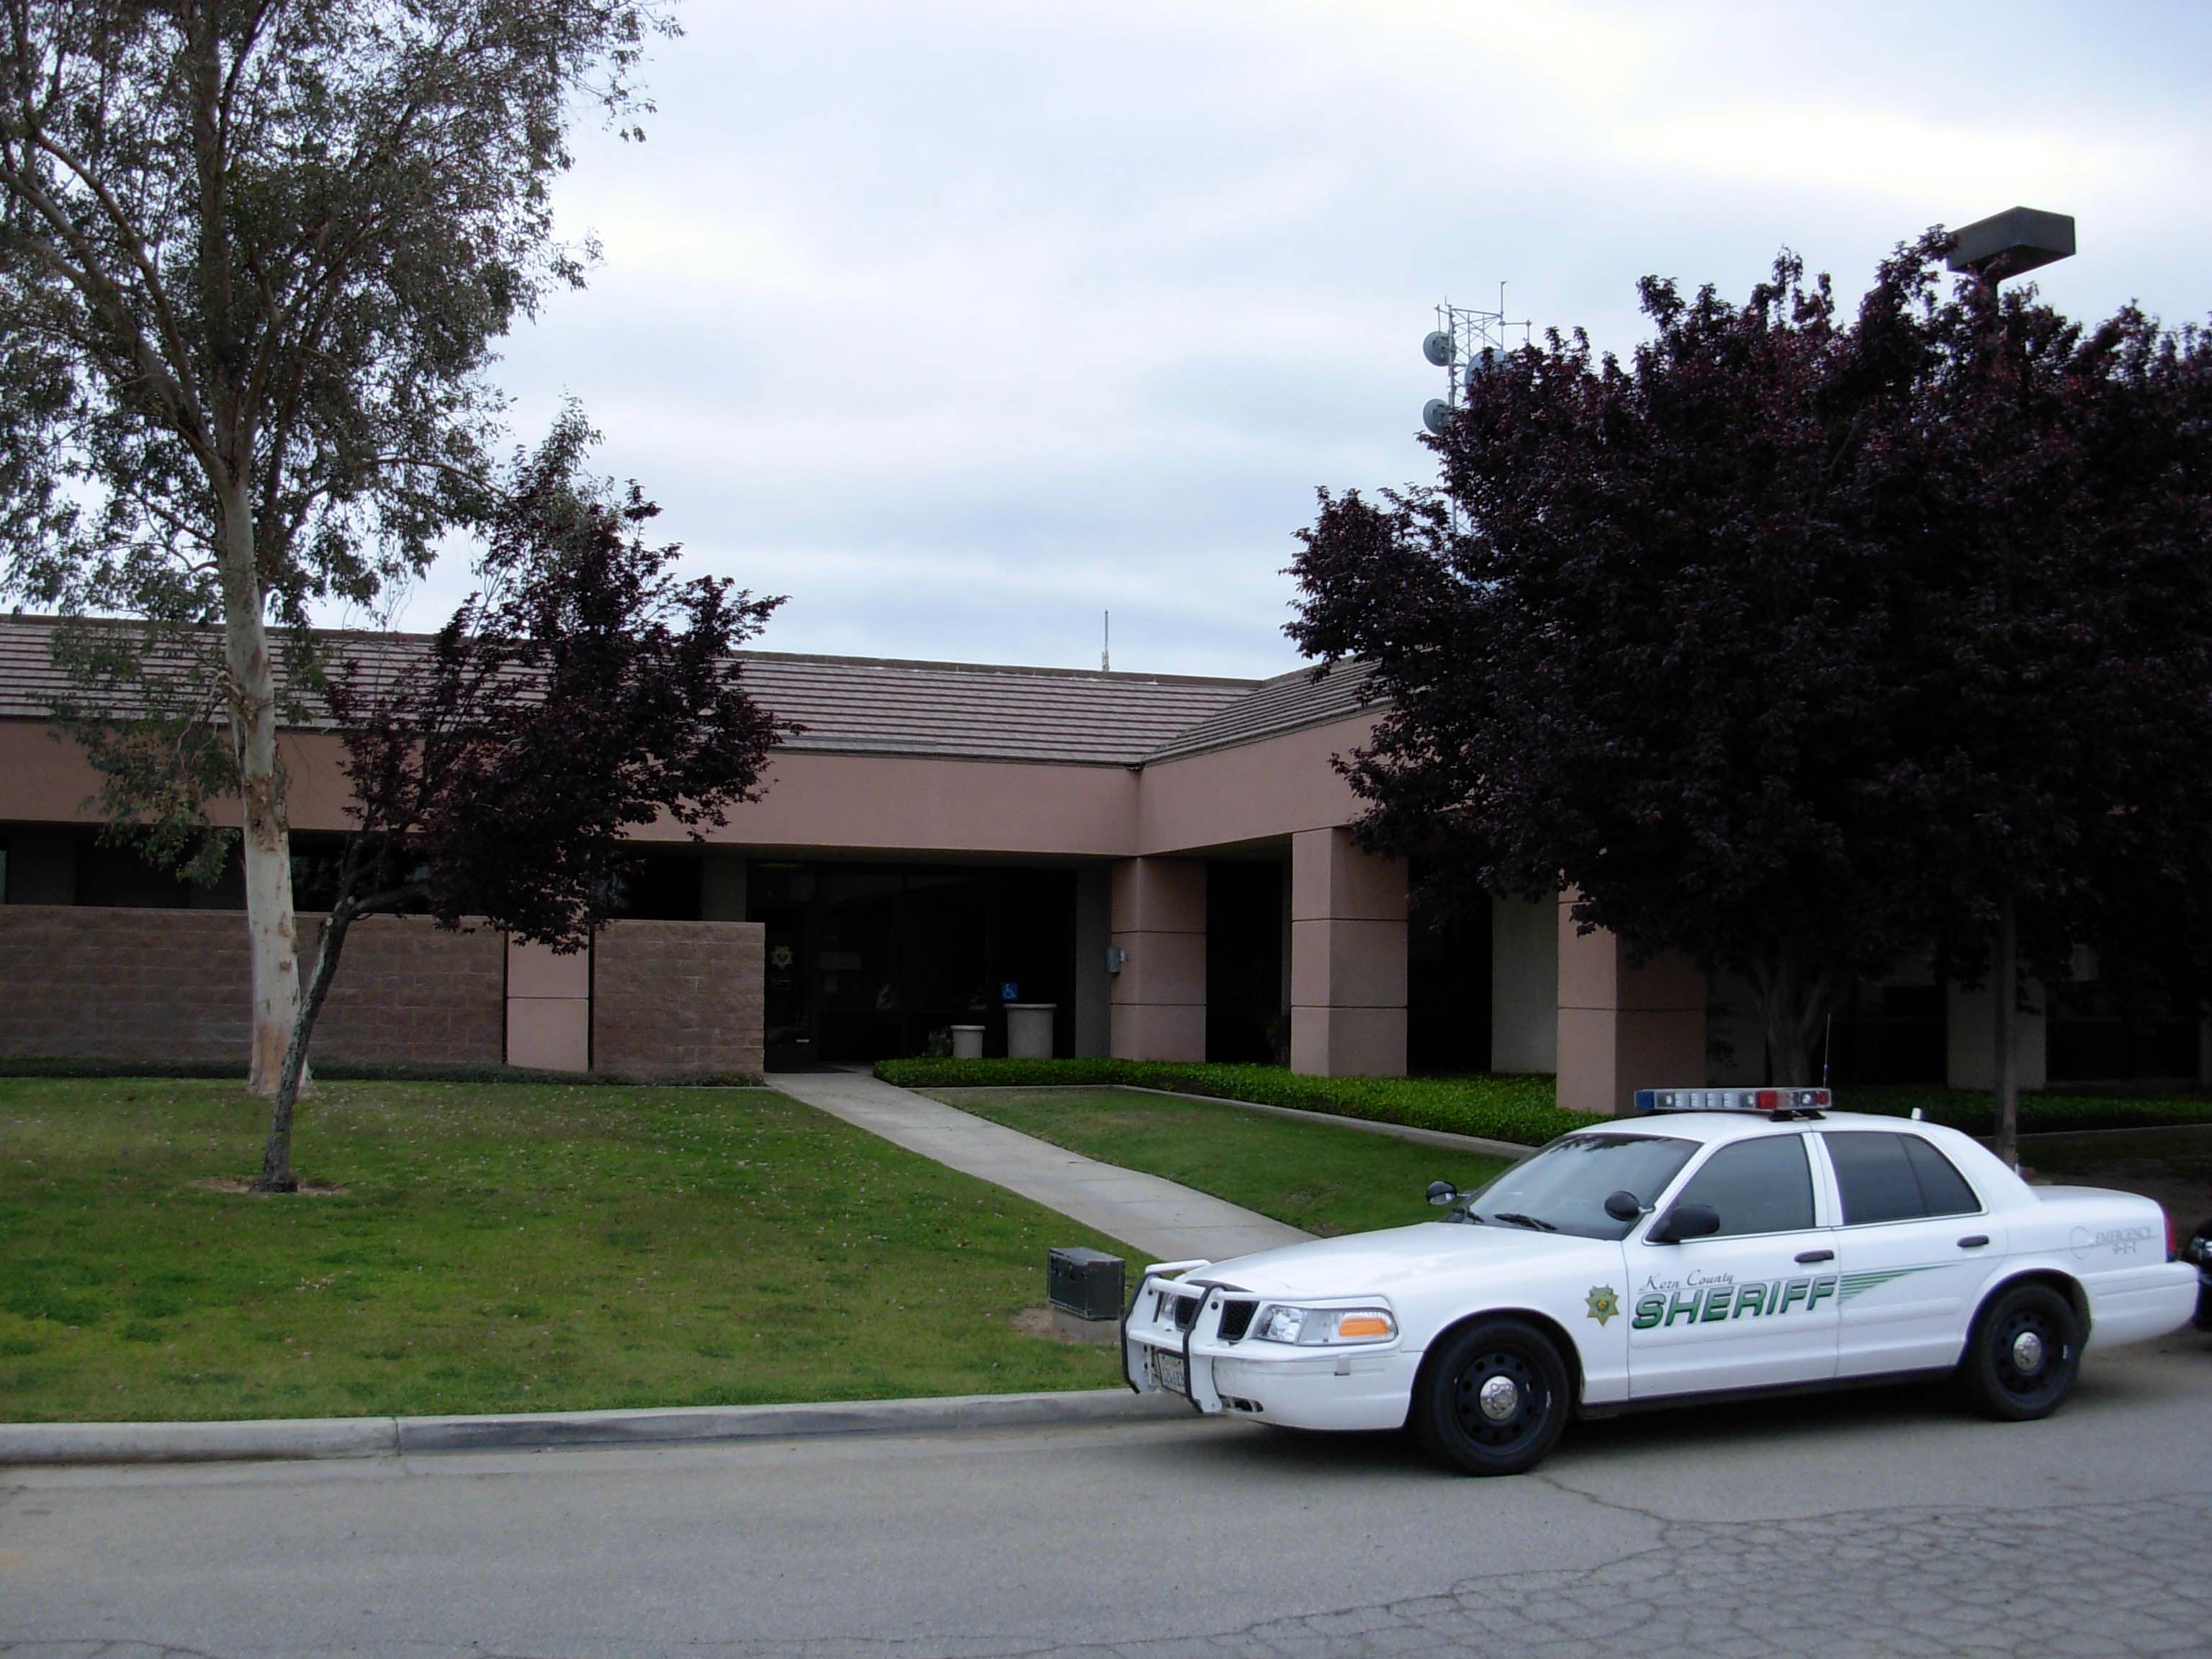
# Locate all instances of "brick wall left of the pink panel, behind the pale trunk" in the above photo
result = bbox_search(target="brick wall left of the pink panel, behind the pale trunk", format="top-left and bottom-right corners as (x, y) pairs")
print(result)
(0, 904), (506, 1066)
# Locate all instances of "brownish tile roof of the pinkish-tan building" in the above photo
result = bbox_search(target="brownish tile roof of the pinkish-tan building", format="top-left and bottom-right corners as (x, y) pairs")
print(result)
(0, 617), (1362, 765)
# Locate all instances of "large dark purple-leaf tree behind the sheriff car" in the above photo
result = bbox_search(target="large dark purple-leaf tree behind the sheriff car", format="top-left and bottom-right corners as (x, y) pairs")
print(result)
(1290, 233), (2212, 1150)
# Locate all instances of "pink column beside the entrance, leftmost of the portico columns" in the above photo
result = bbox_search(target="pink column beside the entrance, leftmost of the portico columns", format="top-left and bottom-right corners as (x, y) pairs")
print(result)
(1106, 858), (1205, 1062)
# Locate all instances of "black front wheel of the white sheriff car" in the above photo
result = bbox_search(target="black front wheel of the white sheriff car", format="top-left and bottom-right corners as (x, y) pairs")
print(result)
(1411, 1318), (1573, 1475)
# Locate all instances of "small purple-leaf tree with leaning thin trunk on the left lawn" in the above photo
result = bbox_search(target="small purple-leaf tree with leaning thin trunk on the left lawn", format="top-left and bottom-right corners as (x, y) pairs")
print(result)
(254, 411), (781, 1192)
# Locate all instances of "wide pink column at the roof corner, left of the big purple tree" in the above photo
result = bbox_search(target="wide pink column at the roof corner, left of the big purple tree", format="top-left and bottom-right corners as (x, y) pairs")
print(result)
(1290, 830), (1406, 1077)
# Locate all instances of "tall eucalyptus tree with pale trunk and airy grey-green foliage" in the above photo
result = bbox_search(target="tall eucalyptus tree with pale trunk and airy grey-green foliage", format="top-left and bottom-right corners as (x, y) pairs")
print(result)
(0, 0), (673, 1090)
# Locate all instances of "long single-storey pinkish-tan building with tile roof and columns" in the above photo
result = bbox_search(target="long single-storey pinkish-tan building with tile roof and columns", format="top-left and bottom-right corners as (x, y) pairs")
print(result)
(0, 619), (2203, 1110)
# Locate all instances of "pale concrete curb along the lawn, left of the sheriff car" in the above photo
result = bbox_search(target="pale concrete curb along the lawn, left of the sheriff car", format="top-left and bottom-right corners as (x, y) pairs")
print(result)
(0, 1389), (1190, 1465)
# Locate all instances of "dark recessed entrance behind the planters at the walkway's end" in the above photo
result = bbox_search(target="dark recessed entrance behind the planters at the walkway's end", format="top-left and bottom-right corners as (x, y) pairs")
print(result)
(745, 863), (1075, 1071)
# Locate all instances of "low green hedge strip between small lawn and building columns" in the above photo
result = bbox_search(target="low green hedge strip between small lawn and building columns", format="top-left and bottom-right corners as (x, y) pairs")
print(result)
(876, 1059), (1591, 1146)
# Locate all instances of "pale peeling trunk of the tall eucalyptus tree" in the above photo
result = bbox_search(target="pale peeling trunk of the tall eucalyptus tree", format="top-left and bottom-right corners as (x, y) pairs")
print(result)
(223, 482), (299, 1095)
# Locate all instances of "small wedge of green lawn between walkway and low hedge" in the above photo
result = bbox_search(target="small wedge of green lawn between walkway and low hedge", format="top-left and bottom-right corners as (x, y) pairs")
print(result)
(929, 1088), (1504, 1234)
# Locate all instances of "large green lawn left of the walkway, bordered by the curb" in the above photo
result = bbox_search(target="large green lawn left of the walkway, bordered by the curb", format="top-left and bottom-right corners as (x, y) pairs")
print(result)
(0, 1077), (1135, 1422)
